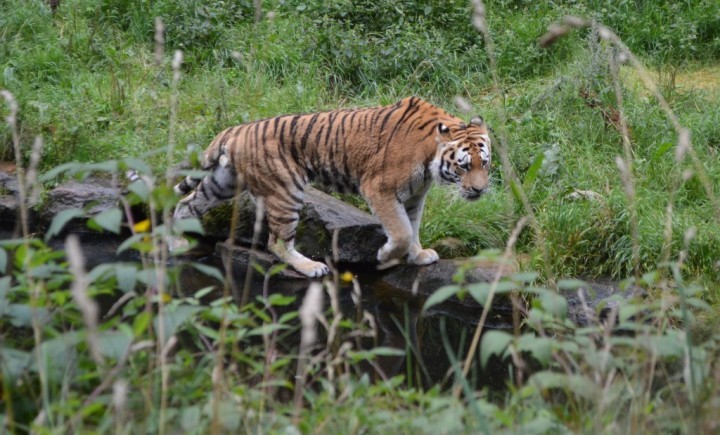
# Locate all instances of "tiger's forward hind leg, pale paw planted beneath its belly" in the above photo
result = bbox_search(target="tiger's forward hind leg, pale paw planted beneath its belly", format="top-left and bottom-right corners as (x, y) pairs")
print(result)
(264, 191), (330, 278)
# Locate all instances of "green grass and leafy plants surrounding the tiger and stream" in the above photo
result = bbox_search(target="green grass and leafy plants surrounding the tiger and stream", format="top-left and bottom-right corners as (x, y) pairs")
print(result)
(0, 0), (720, 432)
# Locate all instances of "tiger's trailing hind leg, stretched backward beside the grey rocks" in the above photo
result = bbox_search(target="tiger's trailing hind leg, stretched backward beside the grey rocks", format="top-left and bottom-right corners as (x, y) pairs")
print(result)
(168, 155), (244, 251)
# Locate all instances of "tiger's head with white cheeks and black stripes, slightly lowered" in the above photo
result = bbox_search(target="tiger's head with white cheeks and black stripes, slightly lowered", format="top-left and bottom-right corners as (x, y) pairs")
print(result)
(430, 116), (491, 201)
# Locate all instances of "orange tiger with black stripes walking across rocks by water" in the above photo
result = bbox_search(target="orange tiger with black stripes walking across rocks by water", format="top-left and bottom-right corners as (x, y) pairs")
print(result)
(171, 96), (491, 278)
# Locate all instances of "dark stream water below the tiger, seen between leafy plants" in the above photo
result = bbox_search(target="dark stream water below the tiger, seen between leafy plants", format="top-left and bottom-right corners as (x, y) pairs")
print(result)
(5, 231), (512, 391)
